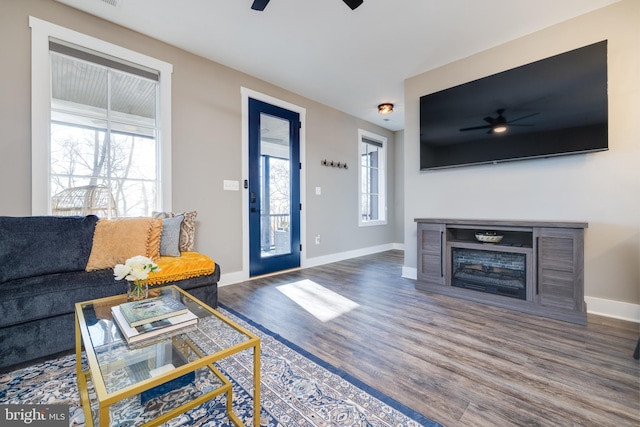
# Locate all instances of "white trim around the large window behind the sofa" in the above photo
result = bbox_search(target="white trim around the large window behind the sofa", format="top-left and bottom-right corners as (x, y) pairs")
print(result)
(29, 16), (173, 215)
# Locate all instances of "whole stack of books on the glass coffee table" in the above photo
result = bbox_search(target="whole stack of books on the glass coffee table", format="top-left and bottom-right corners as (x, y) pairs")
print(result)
(111, 295), (198, 344)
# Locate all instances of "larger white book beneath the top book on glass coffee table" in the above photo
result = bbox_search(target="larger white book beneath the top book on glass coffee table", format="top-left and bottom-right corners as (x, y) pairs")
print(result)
(111, 306), (198, 344)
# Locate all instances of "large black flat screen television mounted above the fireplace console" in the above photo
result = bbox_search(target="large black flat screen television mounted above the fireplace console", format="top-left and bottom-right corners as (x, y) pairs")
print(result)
(420, 40), (609, 170)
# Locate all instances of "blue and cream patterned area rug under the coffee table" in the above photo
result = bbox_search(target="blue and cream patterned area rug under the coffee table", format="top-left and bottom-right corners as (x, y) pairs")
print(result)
(0, 306), (439, 427)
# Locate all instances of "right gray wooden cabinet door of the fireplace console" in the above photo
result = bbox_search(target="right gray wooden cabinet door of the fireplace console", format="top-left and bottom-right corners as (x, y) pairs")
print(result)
(536, 228), (584, 312)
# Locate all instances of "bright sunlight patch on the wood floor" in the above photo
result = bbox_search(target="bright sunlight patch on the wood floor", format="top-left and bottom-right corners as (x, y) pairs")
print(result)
(277, 279), (360, 322)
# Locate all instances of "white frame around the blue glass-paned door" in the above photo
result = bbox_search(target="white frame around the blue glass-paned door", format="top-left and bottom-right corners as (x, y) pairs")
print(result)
(240, 87), (307, 281)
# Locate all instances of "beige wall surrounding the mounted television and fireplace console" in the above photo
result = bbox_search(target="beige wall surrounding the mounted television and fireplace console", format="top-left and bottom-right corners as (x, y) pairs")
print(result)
(404, 0), (640, 308)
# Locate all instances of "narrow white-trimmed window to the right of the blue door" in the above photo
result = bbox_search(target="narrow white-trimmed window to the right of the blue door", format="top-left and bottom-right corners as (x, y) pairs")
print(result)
(358, 129), (387, 226)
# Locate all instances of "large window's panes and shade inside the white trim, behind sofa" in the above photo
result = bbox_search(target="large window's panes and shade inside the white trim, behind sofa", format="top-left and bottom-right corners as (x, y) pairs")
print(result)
(49, 41), (160, 217)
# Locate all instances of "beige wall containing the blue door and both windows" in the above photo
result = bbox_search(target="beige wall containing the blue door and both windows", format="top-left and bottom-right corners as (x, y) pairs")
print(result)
(0, 0), (397, 280)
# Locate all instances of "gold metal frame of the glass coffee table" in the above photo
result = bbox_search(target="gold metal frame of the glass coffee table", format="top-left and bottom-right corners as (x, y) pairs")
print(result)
(75, 286), (260, 427)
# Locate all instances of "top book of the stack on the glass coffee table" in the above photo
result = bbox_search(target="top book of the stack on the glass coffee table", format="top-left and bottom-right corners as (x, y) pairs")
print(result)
(119, 295), (189, 326)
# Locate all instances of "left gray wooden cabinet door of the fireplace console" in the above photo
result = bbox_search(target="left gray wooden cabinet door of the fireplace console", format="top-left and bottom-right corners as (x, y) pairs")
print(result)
(418, 223), (445, 285)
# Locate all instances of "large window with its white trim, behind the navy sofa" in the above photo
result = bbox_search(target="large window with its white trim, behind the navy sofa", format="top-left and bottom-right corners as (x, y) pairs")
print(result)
(30, 18), (171, 217)
